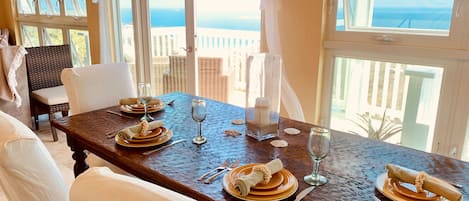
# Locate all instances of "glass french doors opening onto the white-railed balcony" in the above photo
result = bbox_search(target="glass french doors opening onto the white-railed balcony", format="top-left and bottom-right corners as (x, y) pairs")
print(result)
(119, 0), (260, 106)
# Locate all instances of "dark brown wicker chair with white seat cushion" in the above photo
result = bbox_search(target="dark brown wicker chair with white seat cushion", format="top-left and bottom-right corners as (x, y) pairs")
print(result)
(26, 45), (73, 141)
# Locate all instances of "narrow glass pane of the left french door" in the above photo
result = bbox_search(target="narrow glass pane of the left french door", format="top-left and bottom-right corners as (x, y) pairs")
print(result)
(149, 0), (188, 95)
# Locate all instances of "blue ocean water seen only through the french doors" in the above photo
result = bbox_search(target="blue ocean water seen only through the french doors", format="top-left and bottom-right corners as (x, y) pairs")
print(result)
(121, 8), (261, 31)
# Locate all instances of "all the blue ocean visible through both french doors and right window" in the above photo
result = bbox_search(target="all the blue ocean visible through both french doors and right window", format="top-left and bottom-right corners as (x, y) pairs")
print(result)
(121, 7), (451, 31)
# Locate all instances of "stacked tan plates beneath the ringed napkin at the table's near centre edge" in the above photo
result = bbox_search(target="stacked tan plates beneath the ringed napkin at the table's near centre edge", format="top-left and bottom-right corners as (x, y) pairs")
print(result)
(223, 164), (298, 201)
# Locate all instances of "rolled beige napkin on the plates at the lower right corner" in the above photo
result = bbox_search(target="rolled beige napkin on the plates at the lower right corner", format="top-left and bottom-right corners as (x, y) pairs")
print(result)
(386, 164), (462, 201)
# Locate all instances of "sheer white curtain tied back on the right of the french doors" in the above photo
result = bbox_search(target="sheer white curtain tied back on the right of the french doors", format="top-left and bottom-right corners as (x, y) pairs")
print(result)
(260, 0), (305, 121)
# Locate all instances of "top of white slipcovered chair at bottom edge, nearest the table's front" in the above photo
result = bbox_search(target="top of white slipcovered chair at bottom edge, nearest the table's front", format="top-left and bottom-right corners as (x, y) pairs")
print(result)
(70, 167), (194, 201)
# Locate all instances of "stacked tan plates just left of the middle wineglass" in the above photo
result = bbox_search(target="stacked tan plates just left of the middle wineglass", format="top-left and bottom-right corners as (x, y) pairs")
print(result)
(115, 127), (173, 148)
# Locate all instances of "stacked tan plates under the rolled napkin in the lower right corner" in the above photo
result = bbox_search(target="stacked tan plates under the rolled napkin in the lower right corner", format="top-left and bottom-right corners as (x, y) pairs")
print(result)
(376, 173), (441, 201)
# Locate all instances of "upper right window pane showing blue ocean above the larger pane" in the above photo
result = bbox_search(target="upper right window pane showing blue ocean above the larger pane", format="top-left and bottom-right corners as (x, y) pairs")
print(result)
(336, 0), (454, 36)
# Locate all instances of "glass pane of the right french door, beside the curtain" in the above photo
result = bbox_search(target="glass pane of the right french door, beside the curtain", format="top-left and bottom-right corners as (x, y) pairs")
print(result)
(196, 0), (261, 107)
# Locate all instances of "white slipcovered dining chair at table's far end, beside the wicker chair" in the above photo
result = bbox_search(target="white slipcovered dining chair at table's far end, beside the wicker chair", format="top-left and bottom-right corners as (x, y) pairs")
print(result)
(61, 63), (137, 175)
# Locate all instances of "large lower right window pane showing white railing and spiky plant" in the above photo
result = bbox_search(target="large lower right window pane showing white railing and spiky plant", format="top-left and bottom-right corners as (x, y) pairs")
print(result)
(330, 57), (443, 152)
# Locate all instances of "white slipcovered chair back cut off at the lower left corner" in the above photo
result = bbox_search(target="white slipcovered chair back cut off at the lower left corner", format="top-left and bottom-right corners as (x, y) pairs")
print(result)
(0, 111), (68, 201)
